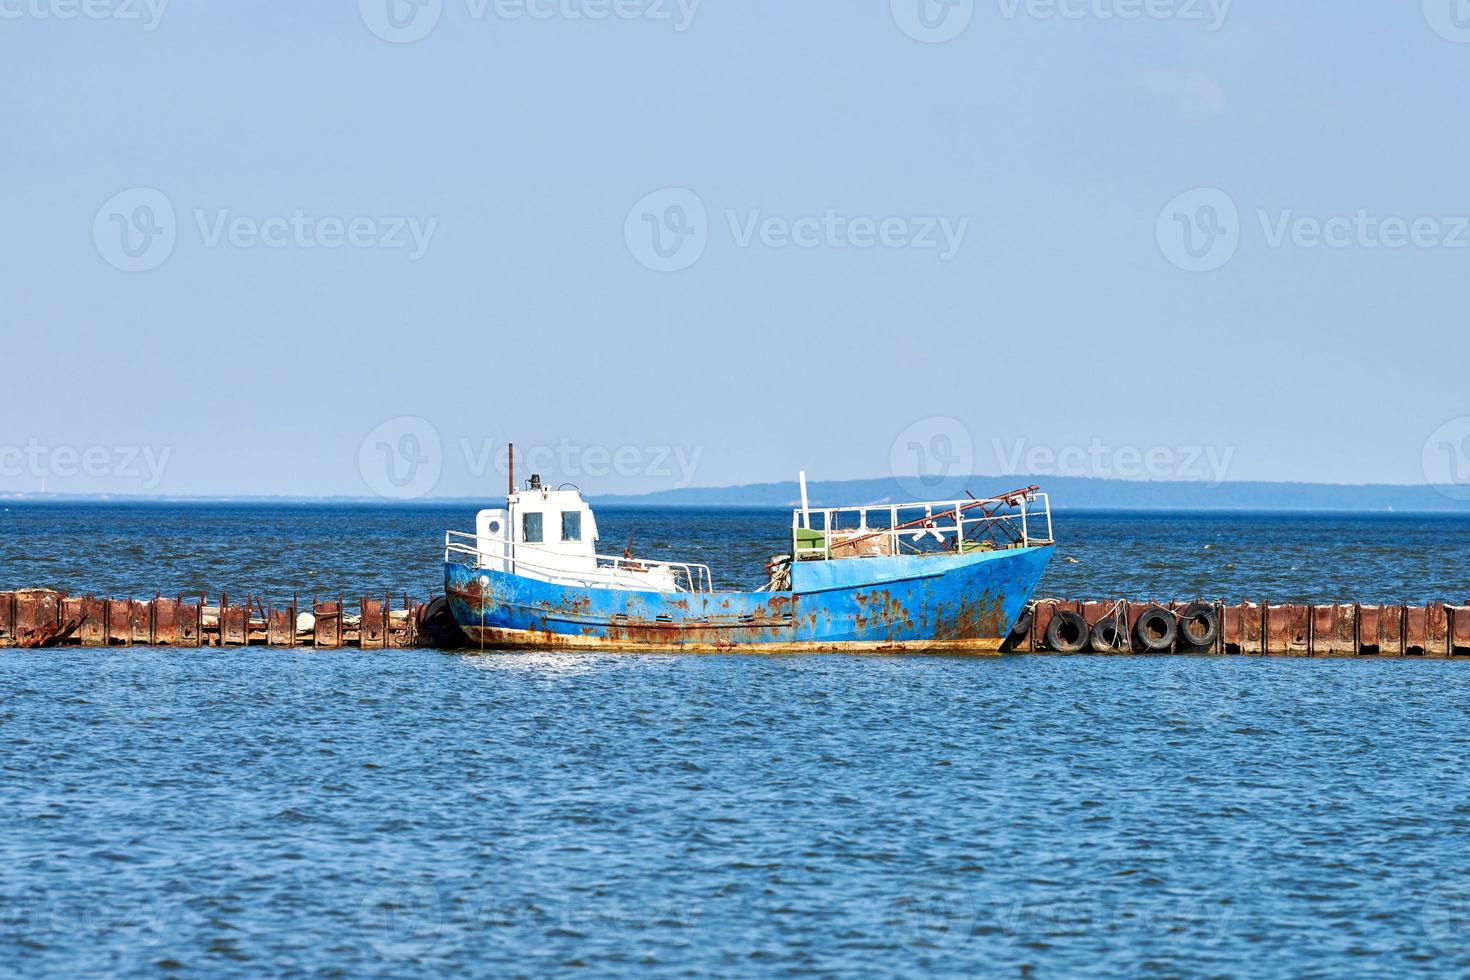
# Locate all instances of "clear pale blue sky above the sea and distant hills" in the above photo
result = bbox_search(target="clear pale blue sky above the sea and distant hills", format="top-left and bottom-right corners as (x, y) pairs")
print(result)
(0, 0), (1470, 495)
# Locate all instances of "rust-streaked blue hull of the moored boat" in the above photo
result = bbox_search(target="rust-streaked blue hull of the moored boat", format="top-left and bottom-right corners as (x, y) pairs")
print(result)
(444, 547), (1053, 652)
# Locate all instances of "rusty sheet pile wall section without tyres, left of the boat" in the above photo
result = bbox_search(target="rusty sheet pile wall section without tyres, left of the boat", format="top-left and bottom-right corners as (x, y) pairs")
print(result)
(0, 591), (425, 649)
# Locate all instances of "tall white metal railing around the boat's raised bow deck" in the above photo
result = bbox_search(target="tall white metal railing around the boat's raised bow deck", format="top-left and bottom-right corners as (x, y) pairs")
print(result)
(791, 486), (1054, 561)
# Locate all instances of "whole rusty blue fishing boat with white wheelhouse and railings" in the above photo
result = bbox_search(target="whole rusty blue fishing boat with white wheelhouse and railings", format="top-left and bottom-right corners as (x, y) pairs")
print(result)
(444, 475), (1054, 654)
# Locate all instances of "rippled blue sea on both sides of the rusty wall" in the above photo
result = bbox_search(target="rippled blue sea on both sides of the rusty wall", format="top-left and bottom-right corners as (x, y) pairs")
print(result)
(0, 504), (1470, 977)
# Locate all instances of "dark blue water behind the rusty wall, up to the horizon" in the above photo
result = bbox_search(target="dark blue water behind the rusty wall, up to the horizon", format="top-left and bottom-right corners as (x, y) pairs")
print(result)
(0, 501), (1470, 602)
